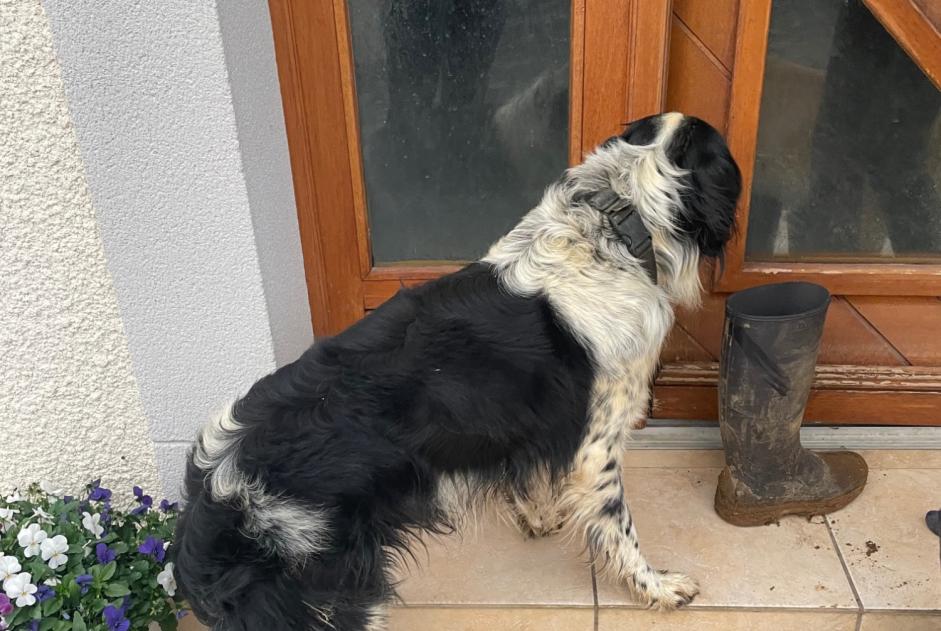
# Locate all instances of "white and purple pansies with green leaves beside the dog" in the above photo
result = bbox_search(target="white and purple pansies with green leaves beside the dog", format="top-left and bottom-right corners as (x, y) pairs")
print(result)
(0, 481), (185, 631)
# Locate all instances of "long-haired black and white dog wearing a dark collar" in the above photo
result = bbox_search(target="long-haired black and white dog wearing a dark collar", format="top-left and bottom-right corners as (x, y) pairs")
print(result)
(174, 113), (740, 631)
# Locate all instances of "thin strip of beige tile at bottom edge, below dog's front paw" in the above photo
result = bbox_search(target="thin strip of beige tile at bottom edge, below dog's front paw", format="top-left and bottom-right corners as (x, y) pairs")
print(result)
(598, 609), (858, 631)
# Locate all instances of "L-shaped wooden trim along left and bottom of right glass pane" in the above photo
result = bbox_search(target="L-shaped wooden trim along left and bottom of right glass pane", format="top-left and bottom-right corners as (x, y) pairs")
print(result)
(714, 0), (941, 296)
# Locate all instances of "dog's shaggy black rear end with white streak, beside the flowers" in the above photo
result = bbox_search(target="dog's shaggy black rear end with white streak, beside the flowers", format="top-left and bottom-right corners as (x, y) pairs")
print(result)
(173, 406), (391, 631)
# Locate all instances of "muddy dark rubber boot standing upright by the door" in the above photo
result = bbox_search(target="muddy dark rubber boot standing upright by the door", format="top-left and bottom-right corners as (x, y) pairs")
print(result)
(715, 283), (869, 526)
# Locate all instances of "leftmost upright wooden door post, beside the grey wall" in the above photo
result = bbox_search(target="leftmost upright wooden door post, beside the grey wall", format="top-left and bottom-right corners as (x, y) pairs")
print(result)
(268, 0), (363, 336)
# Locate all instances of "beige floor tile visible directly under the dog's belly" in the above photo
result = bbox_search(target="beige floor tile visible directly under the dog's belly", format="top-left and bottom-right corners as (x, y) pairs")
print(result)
(399, 508), (594, 607)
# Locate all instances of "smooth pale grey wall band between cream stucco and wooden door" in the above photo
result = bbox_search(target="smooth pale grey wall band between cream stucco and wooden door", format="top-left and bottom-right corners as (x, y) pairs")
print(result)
(43, 0), (311, 502)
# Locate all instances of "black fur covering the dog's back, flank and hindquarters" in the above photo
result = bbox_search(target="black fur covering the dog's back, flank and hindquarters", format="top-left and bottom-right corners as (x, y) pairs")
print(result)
(176, 264), (593, 631)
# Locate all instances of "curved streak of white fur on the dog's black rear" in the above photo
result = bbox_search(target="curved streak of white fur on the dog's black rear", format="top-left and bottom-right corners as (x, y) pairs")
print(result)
(193, 403), (329, 563)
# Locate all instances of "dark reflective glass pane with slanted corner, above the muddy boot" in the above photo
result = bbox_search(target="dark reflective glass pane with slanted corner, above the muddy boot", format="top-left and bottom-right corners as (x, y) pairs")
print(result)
(746, 0), (941, 262)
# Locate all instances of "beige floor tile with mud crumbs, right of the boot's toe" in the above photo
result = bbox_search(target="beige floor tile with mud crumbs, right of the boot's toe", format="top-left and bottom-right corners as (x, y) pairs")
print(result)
(829, 469), (941, 610)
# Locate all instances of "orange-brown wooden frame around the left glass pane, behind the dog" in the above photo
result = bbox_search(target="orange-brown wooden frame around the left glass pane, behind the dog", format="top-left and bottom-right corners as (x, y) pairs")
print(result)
(269, 0), (673, 336)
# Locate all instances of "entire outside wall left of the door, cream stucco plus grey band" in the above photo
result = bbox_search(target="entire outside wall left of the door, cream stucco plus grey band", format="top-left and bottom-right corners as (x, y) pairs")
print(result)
(0, 0), (312, 496)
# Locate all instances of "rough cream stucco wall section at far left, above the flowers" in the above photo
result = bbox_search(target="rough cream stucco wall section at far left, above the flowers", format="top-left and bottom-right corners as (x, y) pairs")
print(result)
(0, 0), (157, 493)
